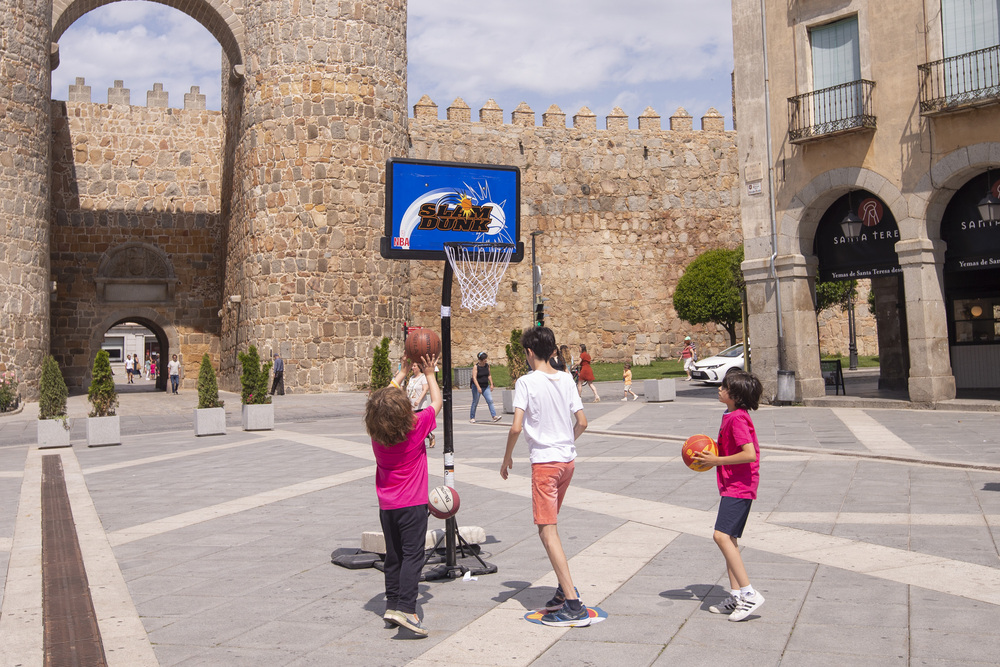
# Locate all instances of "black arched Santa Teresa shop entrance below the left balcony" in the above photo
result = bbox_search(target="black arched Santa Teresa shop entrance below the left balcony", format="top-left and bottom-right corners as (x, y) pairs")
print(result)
(813, 190), (910, 390)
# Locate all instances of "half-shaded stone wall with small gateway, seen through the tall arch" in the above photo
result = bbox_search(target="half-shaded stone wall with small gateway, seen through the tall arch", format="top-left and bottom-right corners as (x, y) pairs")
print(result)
(51, 88), (225, 388)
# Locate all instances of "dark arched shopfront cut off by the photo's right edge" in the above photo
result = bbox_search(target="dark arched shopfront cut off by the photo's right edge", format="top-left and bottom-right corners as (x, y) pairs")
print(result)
(941, 170), (1000, 390)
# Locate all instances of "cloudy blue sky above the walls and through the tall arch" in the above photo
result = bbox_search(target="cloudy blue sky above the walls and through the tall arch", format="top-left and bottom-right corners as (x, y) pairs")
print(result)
(52, 0), (733, 128)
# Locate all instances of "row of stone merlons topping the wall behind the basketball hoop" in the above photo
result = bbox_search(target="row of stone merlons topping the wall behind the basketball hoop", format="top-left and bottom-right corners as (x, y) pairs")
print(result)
(413, 95), (726, 132)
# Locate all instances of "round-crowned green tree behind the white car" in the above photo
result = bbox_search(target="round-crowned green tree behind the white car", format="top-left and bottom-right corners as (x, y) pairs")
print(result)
(674, 246), (744, 345)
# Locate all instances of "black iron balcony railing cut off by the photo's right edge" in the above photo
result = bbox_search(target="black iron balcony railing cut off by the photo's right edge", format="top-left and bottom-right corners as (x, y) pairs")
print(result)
(917, 46), (1000, 116)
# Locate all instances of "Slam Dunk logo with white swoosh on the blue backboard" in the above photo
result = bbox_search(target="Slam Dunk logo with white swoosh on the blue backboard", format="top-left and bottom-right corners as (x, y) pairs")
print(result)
(392, 183), (512, 248)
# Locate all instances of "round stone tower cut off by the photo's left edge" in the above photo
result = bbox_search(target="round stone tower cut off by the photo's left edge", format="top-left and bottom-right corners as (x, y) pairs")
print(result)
(0, 0), (52, 398)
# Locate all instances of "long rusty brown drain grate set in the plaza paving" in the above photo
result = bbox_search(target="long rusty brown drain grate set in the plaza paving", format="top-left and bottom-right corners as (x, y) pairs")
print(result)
(42, 454), (107, 667)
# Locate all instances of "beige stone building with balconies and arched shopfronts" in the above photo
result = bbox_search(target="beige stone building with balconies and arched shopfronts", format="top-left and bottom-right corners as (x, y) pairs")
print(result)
(733, 0), (1000, 404)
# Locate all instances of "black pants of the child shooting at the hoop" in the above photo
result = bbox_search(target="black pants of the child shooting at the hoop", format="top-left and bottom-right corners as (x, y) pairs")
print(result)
(378, 505), (427, 614)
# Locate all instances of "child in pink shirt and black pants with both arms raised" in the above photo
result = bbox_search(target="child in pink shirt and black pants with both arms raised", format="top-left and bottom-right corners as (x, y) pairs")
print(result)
(365, 355), (442, 637)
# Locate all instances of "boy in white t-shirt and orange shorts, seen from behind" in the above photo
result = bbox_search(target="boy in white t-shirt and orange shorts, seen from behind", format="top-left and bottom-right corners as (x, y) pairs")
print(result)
(500, 327), (590, 627)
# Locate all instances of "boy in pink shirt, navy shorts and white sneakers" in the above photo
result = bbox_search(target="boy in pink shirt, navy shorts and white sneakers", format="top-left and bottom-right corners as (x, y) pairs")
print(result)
(694, 370), (764, 621)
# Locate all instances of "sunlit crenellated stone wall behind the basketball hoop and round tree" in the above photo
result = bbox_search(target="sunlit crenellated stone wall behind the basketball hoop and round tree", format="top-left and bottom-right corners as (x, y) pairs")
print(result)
(410, 97), (742, 366)
